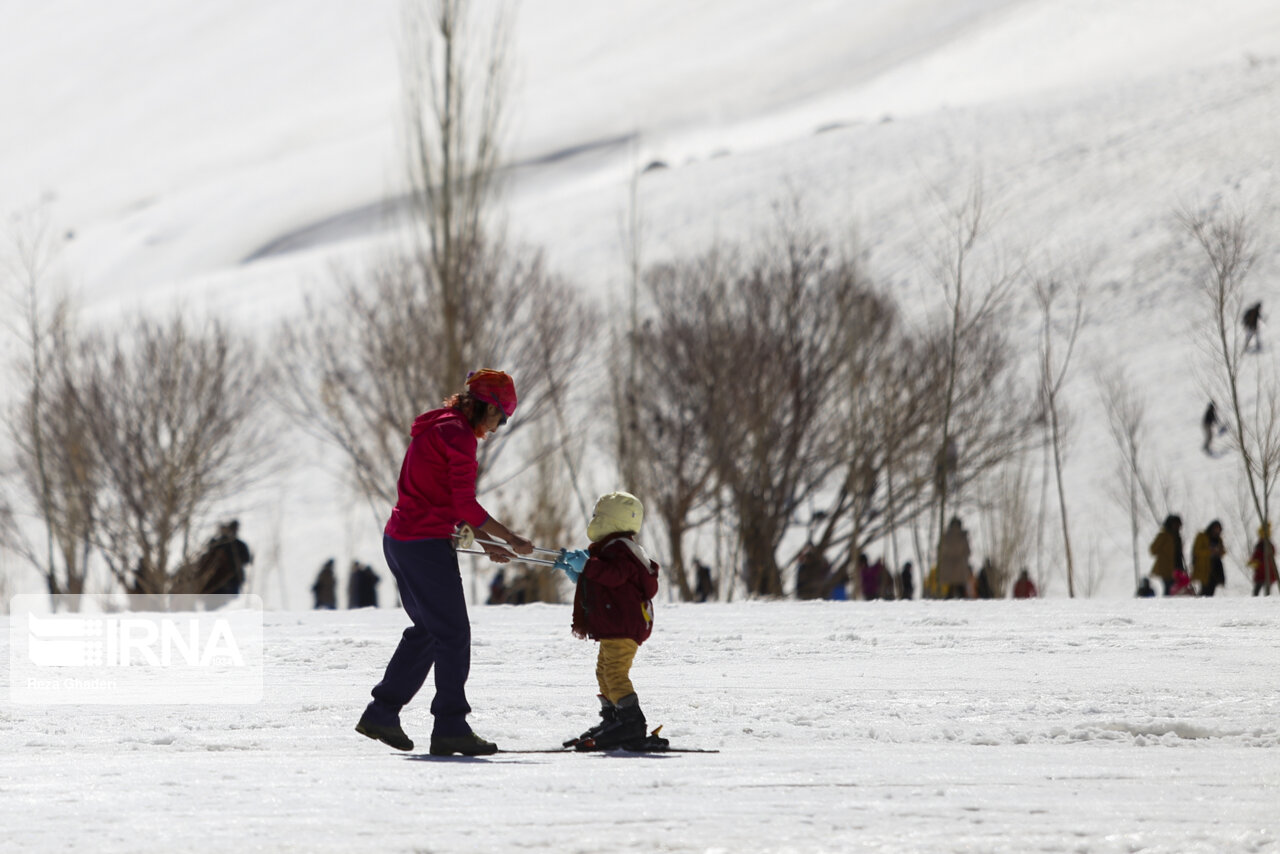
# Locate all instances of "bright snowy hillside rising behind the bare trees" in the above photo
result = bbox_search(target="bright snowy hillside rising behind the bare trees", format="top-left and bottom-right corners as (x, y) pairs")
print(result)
(0, 0), (1280, 607)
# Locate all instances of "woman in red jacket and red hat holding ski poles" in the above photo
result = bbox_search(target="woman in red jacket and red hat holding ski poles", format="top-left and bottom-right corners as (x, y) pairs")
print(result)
(356, 369), (534, 755)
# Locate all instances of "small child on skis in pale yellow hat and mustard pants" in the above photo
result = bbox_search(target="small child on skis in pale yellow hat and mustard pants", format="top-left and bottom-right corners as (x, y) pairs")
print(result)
(556, 492), (667, 750)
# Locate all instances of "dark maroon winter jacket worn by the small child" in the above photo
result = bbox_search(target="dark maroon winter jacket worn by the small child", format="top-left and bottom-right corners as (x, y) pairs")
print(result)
(573, 534), (659, 644)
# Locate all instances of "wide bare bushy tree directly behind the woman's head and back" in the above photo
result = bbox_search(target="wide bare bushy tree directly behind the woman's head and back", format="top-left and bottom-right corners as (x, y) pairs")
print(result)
(279, 257), (595, 519)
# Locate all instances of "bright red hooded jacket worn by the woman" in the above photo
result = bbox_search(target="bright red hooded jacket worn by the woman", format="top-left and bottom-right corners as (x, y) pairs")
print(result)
(384, 408), (489, 540)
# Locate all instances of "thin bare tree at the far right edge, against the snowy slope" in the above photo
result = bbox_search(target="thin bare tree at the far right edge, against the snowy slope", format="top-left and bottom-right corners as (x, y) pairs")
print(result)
(1176, 206), (1280, 547)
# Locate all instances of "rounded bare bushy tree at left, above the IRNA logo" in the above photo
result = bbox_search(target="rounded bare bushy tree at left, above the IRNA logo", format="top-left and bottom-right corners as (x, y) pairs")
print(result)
(63, 319), (274, 593)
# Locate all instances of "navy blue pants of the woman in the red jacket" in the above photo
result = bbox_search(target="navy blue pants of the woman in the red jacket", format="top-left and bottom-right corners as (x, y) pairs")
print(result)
(365, 535), (471, 737)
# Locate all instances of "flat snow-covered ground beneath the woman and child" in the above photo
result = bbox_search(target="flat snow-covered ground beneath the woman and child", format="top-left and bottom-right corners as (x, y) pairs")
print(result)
(0, 598), (1280, 854)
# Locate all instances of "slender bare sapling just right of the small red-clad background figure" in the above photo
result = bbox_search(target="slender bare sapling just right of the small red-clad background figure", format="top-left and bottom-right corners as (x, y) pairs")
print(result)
(1036, 275), (1084, 599)
